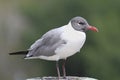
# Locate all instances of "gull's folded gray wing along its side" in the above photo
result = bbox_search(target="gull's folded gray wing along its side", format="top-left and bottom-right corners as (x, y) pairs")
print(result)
(26, 28), (66, 57)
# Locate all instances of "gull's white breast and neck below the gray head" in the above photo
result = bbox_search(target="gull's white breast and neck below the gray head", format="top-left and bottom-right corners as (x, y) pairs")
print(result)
(55, 24), (86, 59)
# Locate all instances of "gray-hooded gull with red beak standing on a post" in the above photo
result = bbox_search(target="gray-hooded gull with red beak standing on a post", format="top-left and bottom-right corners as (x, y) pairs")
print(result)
(9, 16), (98, 78)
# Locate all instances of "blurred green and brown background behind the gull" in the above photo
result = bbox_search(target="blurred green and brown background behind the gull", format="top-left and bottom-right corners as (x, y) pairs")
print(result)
(0, 0), (120, 80)
